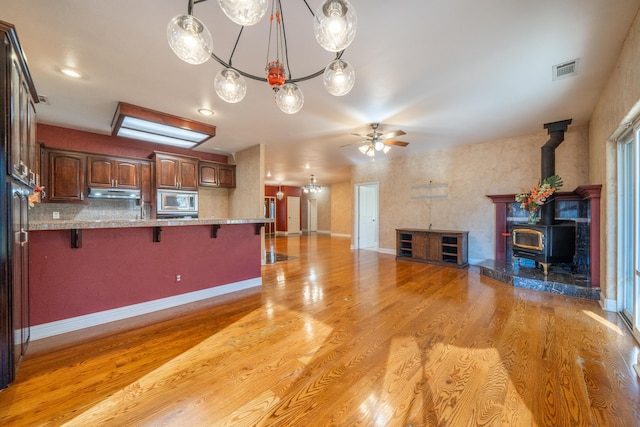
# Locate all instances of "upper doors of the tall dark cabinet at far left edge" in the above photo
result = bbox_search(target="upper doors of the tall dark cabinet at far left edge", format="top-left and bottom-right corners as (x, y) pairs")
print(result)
(0, 21), (40, 187)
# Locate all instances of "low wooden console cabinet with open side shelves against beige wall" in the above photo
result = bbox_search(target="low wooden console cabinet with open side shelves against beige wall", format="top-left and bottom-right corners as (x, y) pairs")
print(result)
(396, 228), (469, 268)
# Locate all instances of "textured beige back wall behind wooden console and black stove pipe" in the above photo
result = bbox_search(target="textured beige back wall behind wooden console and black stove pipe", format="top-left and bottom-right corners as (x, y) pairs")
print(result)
(352, 125), (588, 261)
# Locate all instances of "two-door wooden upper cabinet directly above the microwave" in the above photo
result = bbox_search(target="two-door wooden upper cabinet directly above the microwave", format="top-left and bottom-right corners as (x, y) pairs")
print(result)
(151, 151), (198, 190)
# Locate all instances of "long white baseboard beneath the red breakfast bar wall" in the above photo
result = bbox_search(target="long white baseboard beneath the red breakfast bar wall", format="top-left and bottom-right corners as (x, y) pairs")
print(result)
(31, 277), (262, 341)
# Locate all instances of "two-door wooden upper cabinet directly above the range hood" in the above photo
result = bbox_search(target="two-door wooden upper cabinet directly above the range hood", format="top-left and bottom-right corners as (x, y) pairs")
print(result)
(87, 156), (140, 190)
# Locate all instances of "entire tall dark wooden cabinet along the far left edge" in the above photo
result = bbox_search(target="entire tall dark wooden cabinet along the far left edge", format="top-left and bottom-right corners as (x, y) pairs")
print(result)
(0, 21), (39, 395)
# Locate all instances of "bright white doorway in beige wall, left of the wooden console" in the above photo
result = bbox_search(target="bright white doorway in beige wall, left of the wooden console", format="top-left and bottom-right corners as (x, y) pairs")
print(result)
(354, 183), (379, 250)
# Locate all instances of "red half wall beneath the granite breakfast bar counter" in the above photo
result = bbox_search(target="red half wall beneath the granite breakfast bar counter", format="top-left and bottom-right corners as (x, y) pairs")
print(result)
(29, 224), (261, 325)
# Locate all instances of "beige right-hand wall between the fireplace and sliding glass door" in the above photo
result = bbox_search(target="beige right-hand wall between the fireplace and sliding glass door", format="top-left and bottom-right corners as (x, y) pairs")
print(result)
(589, 10), (640, 309)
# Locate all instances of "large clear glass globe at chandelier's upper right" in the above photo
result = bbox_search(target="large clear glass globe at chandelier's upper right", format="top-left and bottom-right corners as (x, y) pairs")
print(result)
(313, 0), (358, 52)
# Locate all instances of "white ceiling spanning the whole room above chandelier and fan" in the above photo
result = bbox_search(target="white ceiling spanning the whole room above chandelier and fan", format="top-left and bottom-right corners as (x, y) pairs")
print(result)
(0, 0), (640, 185)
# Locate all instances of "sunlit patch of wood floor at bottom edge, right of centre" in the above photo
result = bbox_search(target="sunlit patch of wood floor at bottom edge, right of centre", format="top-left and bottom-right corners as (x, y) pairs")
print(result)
(359, 337), (535, 426)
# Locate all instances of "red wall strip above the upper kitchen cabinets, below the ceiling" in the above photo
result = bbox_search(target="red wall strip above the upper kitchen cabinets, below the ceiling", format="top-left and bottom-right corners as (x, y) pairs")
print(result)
(37, 123), (228, 163)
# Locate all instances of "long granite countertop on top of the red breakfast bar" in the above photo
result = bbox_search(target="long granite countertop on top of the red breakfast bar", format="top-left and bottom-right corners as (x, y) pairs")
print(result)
(29, 218), (274, 231)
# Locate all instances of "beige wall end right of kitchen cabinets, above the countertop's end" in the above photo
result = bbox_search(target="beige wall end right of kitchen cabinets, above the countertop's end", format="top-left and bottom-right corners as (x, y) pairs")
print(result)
(229, 145), (265, 218)
